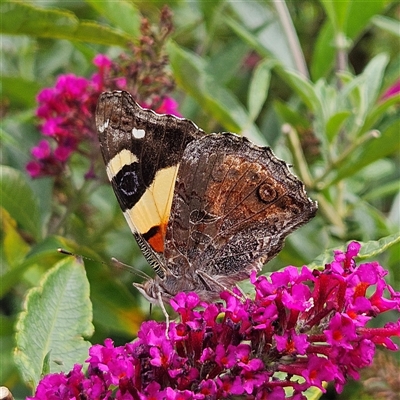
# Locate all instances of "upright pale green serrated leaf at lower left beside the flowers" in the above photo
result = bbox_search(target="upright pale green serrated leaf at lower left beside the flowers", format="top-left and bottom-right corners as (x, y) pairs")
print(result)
(14, 258), (93, 387)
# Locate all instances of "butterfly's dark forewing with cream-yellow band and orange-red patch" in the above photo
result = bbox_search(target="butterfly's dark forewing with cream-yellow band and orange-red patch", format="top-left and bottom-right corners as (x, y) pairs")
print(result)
(96, 91), (203, 270)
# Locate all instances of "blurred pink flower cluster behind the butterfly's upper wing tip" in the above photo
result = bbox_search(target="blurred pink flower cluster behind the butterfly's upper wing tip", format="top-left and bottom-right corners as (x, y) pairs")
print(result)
(26, 54), (179, 178)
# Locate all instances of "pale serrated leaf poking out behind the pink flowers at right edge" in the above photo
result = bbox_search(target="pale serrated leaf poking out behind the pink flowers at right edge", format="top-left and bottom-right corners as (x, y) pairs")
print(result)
(309, 233), (400, 268)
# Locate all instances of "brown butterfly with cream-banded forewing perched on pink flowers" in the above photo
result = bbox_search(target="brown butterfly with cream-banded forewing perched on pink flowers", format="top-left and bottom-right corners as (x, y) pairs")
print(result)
(96, 91), (318, 303)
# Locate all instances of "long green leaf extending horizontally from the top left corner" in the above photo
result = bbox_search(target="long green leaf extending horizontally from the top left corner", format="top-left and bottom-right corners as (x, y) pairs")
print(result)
(0, 1), (132, 46)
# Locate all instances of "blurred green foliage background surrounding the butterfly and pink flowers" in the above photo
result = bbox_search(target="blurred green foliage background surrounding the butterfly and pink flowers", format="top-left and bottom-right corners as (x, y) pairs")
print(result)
(0, 0), (400, 399)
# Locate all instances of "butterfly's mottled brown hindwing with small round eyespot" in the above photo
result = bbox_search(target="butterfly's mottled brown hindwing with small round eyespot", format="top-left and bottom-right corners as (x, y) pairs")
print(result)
(164, 133), (317, 287)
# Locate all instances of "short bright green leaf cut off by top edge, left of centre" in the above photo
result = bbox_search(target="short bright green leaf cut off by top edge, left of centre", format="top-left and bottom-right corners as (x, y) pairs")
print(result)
(86, 0), (141, 38)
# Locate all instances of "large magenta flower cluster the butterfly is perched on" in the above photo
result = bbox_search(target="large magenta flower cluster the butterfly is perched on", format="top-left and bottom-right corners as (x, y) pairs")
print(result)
(30, 242), (400, 400)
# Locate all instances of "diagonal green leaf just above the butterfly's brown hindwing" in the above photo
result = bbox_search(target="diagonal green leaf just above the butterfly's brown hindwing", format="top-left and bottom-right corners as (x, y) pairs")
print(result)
(167, 41), (265, 143)
